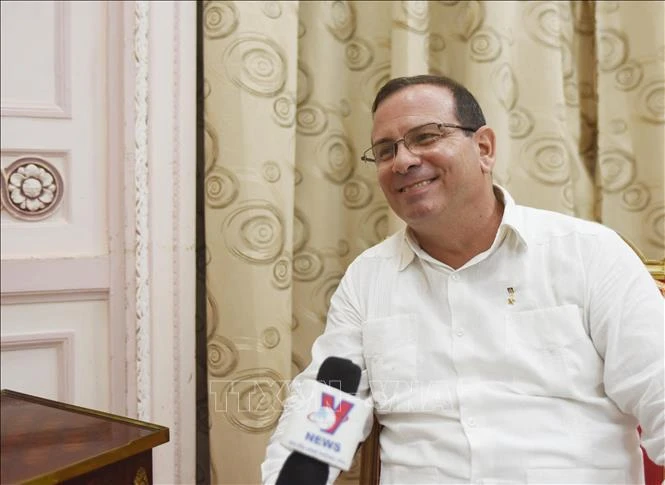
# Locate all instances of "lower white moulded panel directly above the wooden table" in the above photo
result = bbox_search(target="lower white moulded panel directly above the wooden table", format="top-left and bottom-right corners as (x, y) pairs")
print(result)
(0, 300), (110, 411)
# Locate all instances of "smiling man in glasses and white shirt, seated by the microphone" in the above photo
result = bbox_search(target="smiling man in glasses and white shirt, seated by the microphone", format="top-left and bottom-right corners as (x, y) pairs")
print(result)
(263, 76), (665, 484)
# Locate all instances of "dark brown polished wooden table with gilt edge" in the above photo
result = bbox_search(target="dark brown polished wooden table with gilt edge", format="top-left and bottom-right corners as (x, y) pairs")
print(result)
(0, 390), (169, 485)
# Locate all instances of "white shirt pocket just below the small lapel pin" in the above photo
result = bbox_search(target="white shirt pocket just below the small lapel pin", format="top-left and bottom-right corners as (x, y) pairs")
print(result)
(505, 304), (598, 397)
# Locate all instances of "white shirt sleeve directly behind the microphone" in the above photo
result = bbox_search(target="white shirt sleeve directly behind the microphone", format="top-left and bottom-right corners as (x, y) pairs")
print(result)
(261, 265), (373, 485)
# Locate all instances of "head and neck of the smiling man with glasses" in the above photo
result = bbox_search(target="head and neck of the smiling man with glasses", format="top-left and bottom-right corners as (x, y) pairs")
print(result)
(363, 78), (503, 268)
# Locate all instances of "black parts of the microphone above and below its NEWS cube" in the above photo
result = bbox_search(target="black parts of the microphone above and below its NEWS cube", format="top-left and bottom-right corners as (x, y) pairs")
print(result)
(275, 357), (360, 485)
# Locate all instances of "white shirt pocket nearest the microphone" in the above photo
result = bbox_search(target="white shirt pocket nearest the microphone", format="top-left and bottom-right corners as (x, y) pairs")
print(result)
(362, 314), (418, 404)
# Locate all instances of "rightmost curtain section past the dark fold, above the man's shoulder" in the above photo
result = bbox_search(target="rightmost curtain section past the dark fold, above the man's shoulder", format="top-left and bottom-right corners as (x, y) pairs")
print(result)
(594, 1), (665, 250)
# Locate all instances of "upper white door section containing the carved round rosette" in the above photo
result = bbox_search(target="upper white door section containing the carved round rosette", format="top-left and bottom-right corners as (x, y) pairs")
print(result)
(0, 1), (106, 260)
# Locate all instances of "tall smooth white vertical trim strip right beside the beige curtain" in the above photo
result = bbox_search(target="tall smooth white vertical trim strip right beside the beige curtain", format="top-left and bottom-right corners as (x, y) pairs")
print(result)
(148, 2), (196, 483)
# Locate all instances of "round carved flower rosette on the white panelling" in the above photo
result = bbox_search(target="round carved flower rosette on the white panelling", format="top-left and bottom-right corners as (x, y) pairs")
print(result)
(2, 157), (64, 221)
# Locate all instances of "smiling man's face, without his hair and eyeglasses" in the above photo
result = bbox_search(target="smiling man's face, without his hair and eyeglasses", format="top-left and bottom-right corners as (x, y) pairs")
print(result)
(372, 84), (494, 230)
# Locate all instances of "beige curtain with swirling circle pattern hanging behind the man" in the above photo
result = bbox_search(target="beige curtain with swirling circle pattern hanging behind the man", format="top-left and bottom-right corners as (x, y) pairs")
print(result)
(202, 1), (665, 484)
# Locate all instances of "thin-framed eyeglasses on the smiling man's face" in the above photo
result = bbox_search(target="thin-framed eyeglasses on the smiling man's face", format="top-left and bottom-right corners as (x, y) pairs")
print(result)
(360, 123), (478, 163)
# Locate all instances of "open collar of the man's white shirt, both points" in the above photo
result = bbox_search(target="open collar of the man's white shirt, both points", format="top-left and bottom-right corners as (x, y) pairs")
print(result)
(398, 184), (528, 271)
